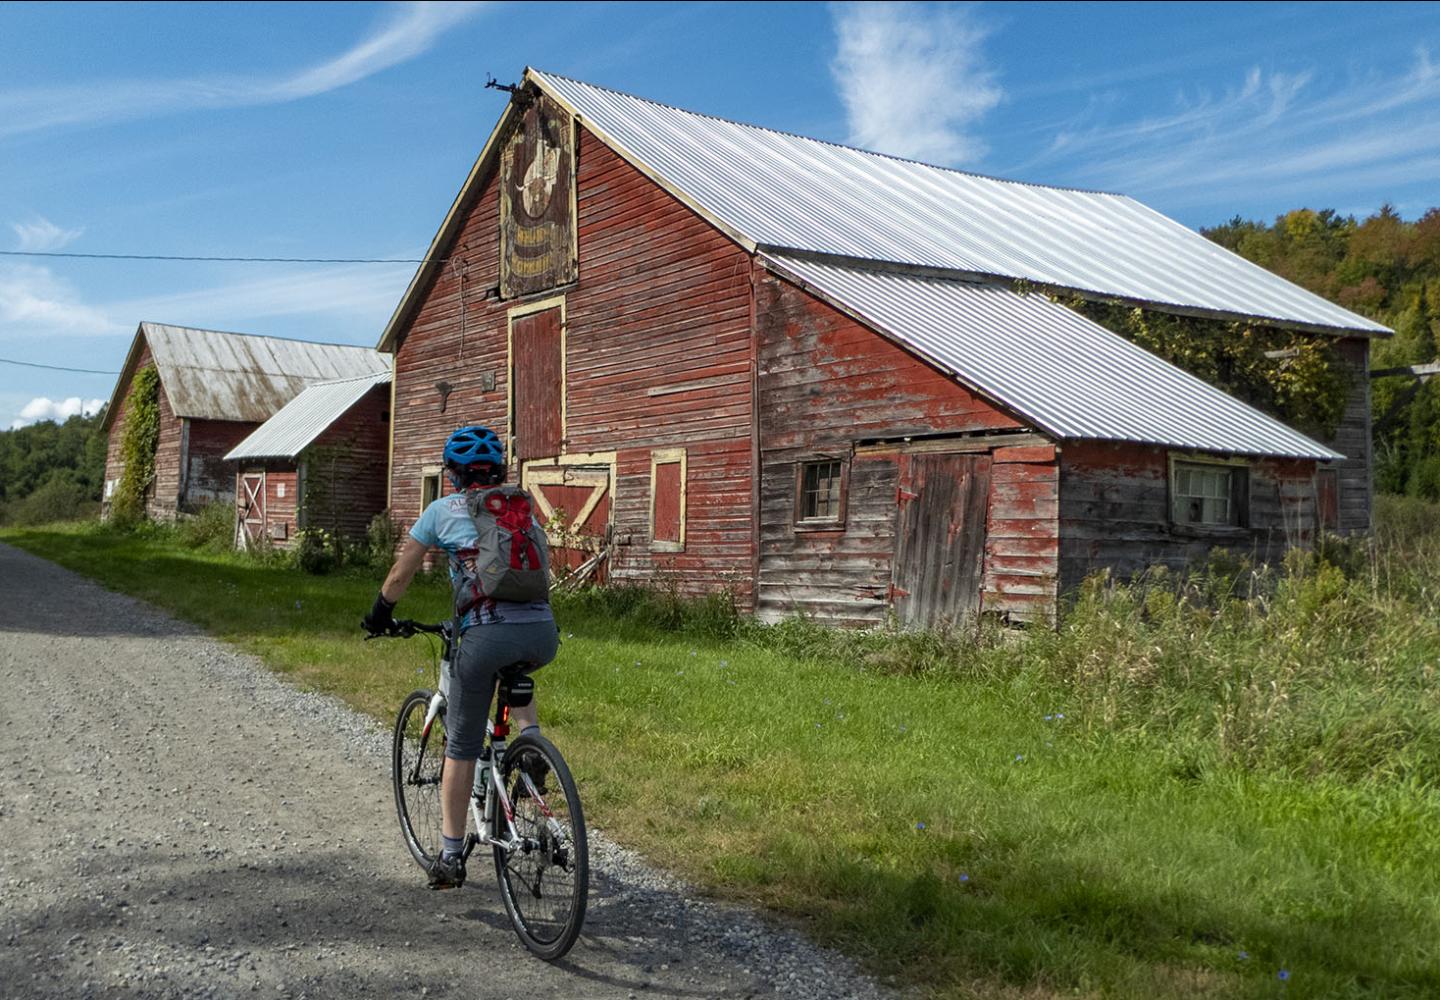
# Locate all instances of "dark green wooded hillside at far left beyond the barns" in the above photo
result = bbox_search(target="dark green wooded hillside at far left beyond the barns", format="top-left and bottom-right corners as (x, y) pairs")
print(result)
(0, 411), (105, 523)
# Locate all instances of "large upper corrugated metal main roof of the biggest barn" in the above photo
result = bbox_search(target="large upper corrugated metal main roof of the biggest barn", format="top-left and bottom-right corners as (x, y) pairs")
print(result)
(526, 69), (1390, 333)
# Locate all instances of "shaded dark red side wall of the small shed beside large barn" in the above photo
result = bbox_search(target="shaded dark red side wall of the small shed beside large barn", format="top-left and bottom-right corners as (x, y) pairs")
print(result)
(292, 385), (390, 539)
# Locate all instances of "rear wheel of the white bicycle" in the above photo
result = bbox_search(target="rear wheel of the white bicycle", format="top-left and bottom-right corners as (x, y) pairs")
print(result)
(494, 736), (590, 961)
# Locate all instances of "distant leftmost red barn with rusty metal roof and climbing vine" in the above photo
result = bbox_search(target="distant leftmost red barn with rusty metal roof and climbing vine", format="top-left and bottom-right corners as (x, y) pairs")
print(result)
(102, 323), (389, 520)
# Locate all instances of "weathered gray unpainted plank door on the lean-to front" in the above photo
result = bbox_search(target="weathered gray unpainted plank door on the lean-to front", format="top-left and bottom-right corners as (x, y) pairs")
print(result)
(891, 455), (991, 625)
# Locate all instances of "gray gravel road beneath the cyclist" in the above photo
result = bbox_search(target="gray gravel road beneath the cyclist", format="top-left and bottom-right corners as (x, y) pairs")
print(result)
(0, 545), (888, 1000)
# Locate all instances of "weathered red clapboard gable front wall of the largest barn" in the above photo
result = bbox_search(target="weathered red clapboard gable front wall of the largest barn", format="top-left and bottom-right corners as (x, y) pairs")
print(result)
(390, 128), (753, 604)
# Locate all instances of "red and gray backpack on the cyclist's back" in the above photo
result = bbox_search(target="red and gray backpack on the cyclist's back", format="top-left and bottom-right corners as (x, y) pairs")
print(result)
(455, 486), (550, 615)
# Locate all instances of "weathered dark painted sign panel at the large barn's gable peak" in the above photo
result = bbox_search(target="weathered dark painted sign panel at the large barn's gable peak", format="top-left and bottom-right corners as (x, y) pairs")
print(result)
(500, 95), (577, 298)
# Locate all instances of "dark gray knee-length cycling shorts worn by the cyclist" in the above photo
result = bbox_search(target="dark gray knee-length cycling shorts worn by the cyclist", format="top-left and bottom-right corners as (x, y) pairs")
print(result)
(444, 620), (560, 761)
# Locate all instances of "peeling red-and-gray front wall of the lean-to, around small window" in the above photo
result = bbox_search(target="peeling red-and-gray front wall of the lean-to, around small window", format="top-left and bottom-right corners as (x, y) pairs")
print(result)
(756, 272), (1042, 625)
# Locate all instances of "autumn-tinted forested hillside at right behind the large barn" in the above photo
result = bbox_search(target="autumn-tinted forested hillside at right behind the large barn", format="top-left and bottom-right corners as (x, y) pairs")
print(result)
(1201, 206), (1440, 500)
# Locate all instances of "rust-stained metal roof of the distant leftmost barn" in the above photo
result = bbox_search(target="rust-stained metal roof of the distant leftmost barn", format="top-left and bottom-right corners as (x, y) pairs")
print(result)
(105, 323), (390, 427)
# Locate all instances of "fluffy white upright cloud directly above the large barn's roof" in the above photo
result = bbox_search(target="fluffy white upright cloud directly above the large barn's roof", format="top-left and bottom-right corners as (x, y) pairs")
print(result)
(831, 3), (1004, 164)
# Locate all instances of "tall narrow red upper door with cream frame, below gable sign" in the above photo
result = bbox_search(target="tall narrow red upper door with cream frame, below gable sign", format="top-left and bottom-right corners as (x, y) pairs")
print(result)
(510, 303), (564, 463)
